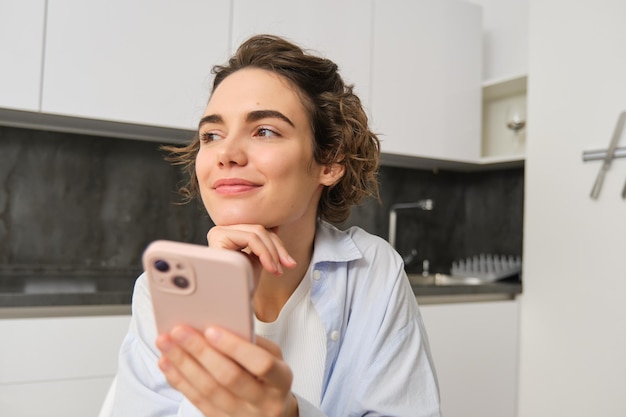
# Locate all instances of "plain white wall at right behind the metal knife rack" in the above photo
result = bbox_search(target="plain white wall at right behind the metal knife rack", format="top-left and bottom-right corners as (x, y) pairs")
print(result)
(519, 0), (626, 417)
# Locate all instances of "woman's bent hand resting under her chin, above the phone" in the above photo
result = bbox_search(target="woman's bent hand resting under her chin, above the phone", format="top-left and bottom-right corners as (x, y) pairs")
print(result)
(207, 224), (296, 278)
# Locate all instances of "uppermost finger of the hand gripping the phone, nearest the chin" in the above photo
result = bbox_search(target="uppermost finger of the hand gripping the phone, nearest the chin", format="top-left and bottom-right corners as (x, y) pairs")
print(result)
(205, 326), (293, 391)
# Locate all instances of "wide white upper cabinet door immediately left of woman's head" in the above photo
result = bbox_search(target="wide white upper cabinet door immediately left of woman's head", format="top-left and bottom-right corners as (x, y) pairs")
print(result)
(42, 0), (230, 130)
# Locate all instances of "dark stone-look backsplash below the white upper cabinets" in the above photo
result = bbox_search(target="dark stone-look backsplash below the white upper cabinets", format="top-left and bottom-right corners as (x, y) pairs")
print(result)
(0, 127), (524, 279)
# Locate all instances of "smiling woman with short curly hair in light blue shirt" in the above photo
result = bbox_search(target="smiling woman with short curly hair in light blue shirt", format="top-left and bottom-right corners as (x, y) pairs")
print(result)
(114, 35), (440, 416)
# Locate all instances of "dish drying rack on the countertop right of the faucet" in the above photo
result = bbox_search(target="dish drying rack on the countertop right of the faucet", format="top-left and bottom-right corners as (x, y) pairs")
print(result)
(450, 254), (522, 282)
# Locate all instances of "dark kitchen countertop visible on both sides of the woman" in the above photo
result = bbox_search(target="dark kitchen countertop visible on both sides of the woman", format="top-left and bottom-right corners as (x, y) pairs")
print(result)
(0, 270), (522, 308)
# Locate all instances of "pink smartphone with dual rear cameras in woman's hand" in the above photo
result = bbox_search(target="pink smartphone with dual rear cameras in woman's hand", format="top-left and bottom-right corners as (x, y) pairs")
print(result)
(142, 240), (254, 341)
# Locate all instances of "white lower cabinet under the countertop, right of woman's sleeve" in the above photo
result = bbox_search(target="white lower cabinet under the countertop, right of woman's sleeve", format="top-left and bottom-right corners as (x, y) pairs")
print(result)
(420, 300), (519, 417)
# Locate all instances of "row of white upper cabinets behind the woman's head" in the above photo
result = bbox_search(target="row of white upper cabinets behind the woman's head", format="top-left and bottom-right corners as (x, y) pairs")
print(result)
(0, 0), (490, 167)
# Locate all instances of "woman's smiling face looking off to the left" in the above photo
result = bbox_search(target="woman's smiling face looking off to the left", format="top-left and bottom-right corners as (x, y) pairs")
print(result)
(196, 68), (336, 228)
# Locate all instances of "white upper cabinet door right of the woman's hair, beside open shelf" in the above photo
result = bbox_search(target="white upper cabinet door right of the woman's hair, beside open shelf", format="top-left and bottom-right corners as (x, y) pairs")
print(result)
(371, 0), (481, 162)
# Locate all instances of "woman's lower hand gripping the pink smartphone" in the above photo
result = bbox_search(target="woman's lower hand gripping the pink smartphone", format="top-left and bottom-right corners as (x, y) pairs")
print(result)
(157, 326), (298, 417)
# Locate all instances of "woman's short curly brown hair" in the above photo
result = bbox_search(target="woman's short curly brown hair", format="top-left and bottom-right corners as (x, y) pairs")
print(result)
(163, 35), (380, 223)
